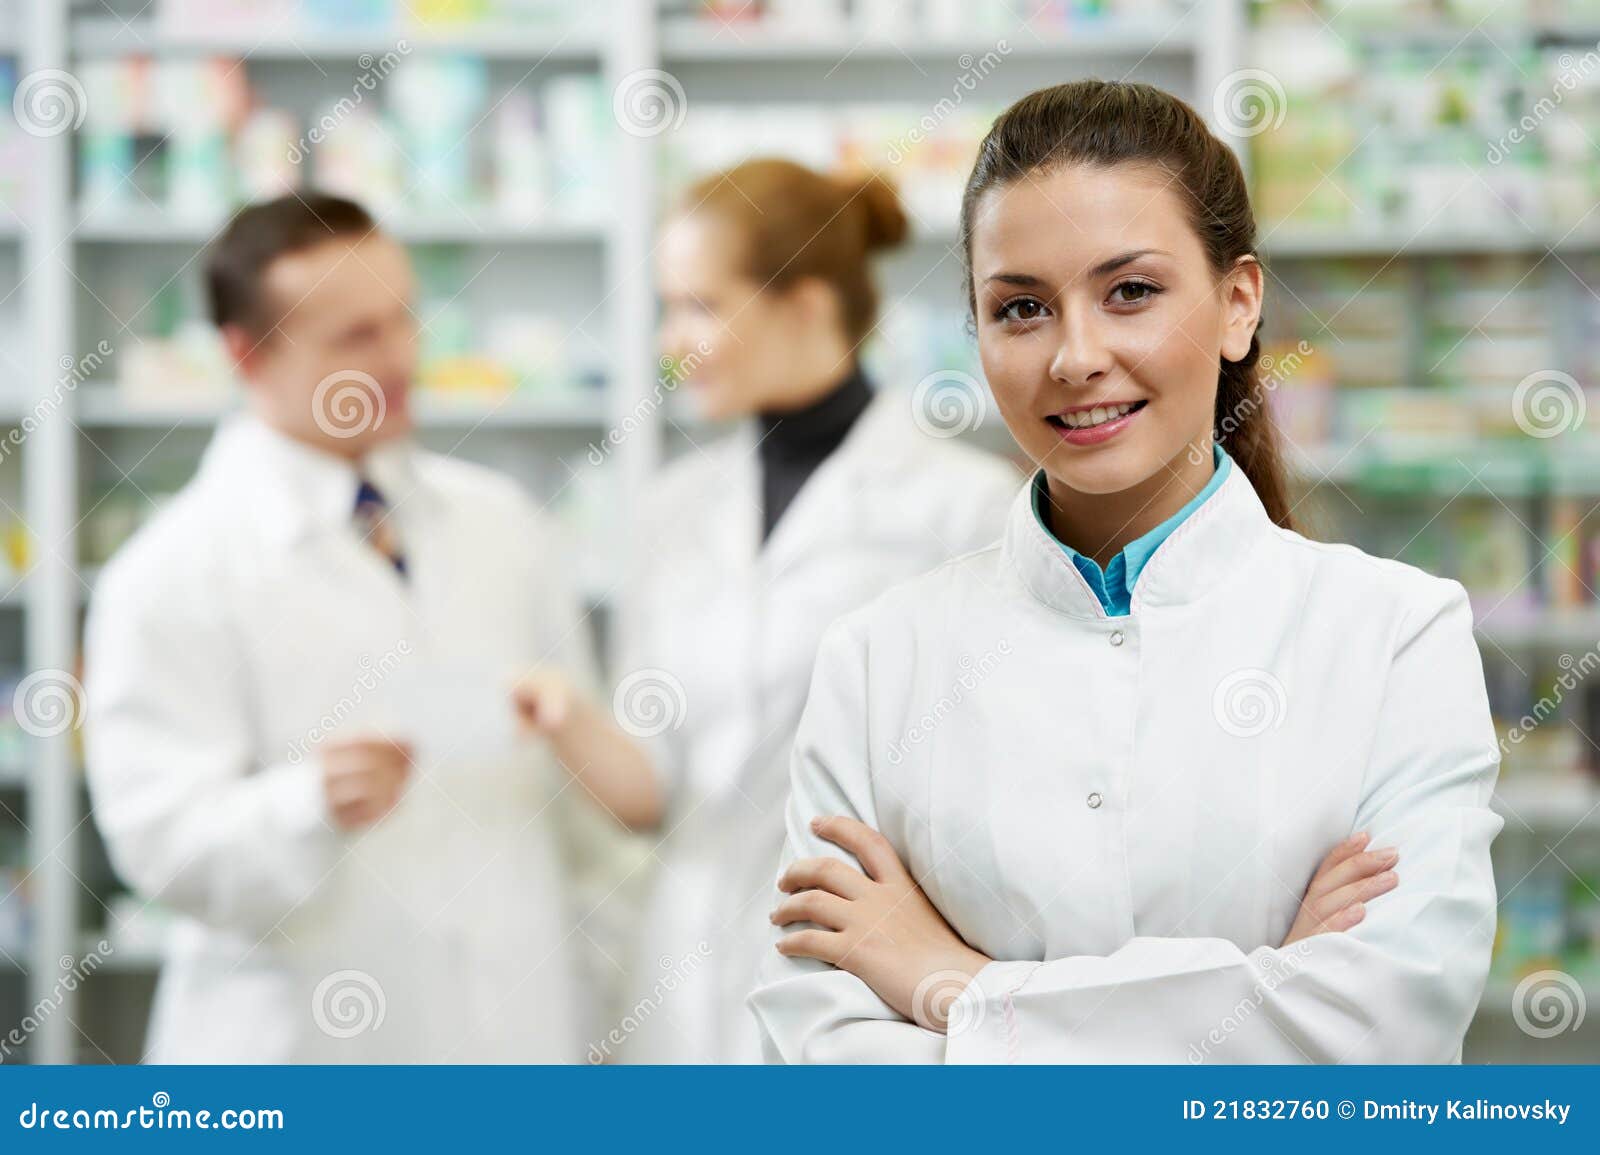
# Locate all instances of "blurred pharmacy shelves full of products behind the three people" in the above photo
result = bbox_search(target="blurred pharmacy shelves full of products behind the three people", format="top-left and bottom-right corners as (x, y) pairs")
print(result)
(0, 0), (1600, 1062)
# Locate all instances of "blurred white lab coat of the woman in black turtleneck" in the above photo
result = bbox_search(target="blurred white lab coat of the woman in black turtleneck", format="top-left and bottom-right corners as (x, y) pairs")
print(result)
(618, 390), (1018, 1062)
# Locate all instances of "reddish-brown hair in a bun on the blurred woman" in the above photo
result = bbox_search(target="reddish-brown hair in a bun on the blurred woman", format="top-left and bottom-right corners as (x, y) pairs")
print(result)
(678, 160), (907, 344)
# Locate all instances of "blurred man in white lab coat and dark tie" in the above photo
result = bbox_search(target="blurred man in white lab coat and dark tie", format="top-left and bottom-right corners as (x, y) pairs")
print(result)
(79, 195), (658, 1062)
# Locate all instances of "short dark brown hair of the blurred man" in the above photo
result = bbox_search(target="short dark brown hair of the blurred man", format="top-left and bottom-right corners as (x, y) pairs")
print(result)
(205, 192), (378, 333)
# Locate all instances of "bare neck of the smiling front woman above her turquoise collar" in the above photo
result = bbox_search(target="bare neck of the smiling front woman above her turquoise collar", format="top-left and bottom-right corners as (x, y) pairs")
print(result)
(1045, 432), (1216, 570)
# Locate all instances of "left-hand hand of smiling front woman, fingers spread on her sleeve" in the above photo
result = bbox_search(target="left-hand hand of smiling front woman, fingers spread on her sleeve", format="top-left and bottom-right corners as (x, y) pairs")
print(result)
(773, 817), (989, 1033)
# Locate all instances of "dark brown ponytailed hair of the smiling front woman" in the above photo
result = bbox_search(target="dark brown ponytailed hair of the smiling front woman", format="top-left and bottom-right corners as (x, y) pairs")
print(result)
(962, 80), (1294, 530)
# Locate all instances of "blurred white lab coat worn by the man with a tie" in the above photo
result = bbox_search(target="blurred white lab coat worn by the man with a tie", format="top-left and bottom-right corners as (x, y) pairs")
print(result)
(86, 418), (592, 1062)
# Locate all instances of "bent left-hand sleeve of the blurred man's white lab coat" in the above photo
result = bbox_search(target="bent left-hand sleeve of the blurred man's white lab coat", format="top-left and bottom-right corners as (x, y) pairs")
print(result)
(85, 563), (339, 936)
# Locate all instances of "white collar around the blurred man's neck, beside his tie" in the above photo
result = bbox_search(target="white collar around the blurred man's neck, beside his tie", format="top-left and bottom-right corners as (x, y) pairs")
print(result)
(200, 413), (432, 544)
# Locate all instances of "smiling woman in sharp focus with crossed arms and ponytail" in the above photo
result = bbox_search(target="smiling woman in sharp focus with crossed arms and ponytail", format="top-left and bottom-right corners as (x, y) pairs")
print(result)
(750, 82), (1501, 1062)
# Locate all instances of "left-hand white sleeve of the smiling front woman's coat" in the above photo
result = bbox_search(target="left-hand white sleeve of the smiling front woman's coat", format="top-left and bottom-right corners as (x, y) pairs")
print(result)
(749, 617), (944, 1064)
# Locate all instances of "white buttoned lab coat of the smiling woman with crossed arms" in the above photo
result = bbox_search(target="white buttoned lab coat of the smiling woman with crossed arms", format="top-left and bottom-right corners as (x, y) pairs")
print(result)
(750, 457), (1501, 1064)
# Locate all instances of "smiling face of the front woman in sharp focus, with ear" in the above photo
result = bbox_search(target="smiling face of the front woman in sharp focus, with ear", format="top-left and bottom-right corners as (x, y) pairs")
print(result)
(971, 165), (1261, 493)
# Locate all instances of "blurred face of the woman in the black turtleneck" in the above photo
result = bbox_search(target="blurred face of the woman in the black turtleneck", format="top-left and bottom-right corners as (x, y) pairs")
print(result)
(656, 213), (808, 421)
